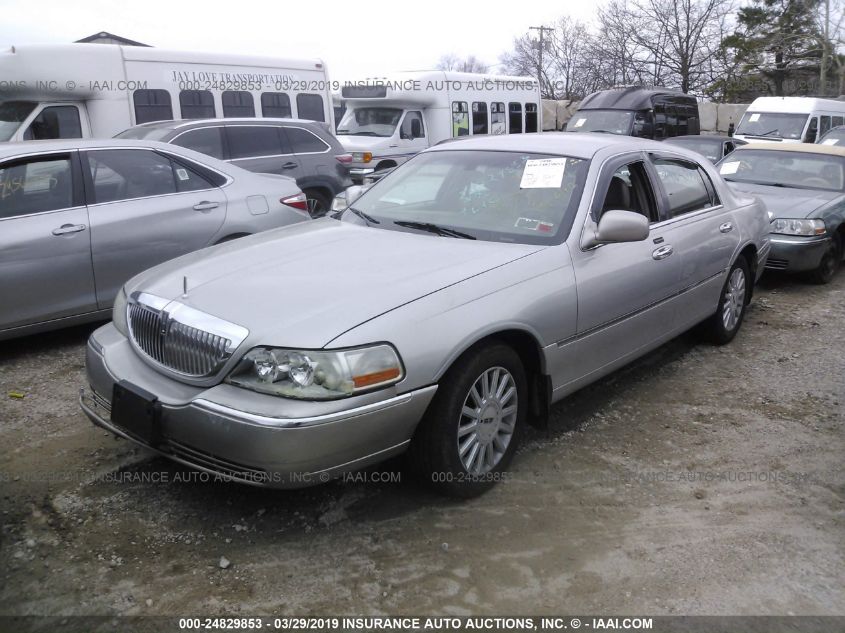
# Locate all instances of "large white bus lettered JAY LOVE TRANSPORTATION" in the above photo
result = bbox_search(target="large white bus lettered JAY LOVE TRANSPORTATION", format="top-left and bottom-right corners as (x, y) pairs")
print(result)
(0, 44), (334, 141)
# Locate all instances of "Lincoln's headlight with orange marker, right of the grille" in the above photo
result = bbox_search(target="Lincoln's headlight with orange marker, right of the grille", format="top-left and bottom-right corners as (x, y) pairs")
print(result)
(226, 343), (405, 400)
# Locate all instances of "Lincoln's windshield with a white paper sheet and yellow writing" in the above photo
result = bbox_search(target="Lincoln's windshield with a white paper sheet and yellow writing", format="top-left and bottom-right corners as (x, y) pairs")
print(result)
(343, 150), (589, 244)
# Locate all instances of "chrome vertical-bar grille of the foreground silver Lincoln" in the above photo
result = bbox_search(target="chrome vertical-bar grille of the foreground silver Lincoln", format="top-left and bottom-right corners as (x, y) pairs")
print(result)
(127, 294), (248, 378)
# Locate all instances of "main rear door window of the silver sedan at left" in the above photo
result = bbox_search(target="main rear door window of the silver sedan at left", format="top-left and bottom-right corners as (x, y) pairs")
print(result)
(87, 149), (177, 204)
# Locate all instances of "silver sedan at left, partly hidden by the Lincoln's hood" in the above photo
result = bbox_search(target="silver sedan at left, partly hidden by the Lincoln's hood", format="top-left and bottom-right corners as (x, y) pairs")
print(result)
(0, 140), (309, 340)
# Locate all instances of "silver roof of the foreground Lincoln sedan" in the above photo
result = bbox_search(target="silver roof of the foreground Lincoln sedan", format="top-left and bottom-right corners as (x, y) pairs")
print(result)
(426, 132), (664, 159)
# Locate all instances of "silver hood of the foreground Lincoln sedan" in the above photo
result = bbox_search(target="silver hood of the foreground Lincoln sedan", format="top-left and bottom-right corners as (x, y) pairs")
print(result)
(127, 218), (544, 349)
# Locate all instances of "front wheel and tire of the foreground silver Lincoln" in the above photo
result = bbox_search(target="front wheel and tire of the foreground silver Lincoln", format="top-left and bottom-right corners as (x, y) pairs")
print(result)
(409, 343), (528, 498)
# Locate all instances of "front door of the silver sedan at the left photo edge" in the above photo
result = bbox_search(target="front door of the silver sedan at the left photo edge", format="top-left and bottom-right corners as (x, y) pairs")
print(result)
(0, 151), (97, 330)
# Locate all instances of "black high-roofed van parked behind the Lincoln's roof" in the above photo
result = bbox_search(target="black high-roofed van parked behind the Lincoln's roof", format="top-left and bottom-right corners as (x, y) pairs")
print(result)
(566, 87), (701, 140)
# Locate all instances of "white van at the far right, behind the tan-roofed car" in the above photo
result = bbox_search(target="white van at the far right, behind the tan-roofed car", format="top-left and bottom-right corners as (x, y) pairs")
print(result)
(734, 97), (845, 143)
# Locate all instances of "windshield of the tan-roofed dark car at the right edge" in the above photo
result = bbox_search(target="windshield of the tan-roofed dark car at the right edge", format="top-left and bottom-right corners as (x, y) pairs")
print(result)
(719, 149), (845, 191)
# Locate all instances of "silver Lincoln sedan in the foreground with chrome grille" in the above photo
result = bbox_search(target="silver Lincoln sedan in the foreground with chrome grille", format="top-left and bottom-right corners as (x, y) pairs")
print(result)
(81, 133), (769, 496)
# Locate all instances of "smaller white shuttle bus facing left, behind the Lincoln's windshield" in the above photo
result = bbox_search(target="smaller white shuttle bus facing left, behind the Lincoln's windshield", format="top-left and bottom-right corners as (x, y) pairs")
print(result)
(337, 71), (543, 182)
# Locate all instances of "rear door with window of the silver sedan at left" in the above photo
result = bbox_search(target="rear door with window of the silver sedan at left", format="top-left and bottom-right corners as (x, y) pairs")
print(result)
(83, 148), (226, 308)
